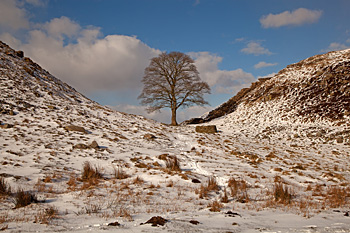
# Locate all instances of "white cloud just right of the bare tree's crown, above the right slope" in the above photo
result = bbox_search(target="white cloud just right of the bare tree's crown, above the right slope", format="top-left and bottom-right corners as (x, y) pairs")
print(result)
(189, 52), (255, 94)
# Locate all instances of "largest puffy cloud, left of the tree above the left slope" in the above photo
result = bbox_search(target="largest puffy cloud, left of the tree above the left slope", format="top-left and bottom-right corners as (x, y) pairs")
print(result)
(2, 17), (160, 92)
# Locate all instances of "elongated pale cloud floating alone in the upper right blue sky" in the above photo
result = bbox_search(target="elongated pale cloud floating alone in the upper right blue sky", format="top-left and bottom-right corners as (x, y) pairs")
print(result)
(260, 8), (322, 28)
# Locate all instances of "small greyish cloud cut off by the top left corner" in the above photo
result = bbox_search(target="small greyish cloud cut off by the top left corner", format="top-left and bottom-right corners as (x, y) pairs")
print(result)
(0, 0), (29, 31)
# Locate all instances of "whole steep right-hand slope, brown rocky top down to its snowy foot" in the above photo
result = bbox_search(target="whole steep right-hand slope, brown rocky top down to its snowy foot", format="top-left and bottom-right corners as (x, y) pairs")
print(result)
(190, 50), (350, 143)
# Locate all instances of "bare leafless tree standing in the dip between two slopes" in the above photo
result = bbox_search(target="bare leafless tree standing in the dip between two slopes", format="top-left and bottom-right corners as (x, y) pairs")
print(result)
(138, 52), (210, 125)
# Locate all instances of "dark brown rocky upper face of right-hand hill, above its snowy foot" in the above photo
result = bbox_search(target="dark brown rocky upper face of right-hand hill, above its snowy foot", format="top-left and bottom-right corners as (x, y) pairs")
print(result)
(189, 50), (350, 123)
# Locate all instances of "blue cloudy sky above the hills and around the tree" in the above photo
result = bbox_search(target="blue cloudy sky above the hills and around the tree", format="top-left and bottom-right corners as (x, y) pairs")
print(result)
(0, 0), (350, 123)
